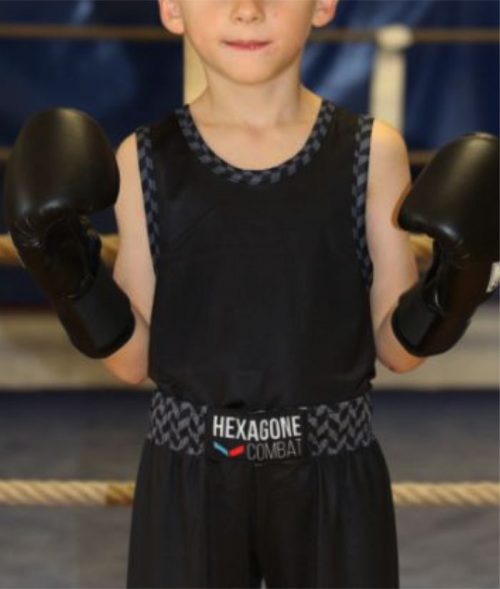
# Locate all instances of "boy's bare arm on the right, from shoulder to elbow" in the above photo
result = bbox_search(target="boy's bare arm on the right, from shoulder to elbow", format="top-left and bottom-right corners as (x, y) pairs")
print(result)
(365, 119), (425, 372)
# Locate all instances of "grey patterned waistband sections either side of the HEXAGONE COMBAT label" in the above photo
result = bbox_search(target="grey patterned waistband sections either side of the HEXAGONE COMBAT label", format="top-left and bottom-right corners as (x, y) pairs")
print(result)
(146, 389), (374, 456)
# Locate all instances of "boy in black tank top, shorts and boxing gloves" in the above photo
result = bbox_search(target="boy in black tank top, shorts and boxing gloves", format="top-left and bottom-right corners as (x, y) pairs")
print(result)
(6, 0), (498, 587)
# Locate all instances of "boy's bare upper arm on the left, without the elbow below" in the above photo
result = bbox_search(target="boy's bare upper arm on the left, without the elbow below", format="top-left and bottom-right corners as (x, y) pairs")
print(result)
(113, 133), (155, 324)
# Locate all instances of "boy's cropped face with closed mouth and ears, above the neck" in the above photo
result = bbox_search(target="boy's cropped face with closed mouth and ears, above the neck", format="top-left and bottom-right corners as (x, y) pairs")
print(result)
(159, 0), (337, 83)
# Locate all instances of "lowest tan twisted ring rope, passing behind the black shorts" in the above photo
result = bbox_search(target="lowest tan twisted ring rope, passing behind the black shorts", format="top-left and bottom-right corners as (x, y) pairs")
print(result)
(0, 479), (500, 507)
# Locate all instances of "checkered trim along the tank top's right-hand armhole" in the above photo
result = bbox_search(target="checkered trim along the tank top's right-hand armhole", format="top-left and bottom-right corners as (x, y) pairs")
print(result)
(351, 114), (373, 291)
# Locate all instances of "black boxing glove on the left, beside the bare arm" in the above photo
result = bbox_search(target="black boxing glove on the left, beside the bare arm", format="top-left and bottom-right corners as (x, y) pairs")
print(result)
(4, 108), (135, 358)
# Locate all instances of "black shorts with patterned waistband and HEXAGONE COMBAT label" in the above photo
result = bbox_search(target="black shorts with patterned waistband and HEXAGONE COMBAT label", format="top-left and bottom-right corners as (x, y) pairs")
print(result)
(127, 391), (399, 588)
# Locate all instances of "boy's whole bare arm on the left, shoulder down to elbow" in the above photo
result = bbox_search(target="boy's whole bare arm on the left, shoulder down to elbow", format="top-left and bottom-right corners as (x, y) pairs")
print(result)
(102, 133), (156, 384)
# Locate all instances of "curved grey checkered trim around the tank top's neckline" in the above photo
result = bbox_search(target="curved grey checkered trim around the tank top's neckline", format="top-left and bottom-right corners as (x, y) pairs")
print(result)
(175, 99), (335, 186)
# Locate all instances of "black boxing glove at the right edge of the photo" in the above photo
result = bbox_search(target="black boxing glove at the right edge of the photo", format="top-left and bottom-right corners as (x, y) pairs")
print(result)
(391, 133), (500, 357)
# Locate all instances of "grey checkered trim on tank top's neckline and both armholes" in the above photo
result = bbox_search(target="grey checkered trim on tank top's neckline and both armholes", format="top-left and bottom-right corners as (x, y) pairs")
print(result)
(136, 105), (373, 290)
